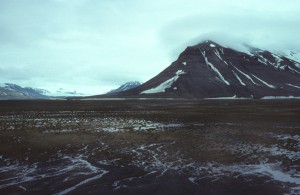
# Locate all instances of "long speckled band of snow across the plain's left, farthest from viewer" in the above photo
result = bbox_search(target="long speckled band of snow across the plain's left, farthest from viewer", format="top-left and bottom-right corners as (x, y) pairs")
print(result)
(0, 112), (183, 133)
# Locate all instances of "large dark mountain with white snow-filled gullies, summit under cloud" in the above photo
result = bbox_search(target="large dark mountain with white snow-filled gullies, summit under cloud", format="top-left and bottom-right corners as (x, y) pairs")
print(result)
(99, 40), (300, 98)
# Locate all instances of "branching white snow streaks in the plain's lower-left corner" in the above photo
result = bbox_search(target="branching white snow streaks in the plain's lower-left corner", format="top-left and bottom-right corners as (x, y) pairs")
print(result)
(0, 153), (108, 195)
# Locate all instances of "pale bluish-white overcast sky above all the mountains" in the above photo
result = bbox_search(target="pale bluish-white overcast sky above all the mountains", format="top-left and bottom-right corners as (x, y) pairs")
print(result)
(0, 0), (300, 94)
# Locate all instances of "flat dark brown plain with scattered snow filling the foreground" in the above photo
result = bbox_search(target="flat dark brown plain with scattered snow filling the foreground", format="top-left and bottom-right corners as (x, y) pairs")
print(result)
(0, 100), (300, 195)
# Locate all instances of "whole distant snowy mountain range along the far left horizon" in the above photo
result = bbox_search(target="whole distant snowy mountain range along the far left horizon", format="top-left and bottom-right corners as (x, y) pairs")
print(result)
(0, 83), (88, 100)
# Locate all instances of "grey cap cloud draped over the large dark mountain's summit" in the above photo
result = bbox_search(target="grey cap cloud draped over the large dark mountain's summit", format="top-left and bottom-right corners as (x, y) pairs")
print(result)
(160, 9), (300, 57)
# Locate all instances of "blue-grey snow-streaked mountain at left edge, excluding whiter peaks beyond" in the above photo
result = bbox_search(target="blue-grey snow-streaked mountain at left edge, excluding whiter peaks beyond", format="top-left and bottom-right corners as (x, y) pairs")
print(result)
(0, 83), (47, 99)
